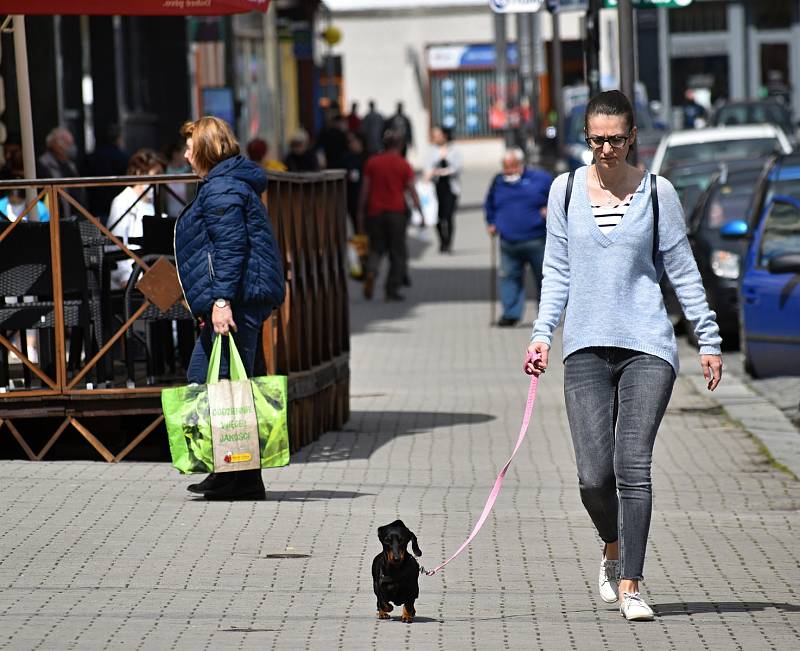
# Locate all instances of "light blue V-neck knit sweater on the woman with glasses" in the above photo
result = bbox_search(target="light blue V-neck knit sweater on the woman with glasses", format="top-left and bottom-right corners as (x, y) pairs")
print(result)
(531, 167), (722, 374)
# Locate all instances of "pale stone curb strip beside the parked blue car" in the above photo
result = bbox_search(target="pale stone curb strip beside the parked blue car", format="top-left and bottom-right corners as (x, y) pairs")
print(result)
(678, 340), (800, 479)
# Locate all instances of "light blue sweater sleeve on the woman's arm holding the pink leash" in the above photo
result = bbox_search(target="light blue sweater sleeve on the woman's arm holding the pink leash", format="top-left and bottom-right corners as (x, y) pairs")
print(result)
(531, 174), (569, 346)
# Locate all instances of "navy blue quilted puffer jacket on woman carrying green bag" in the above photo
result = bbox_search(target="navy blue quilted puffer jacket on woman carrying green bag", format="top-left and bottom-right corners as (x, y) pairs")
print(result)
(175, 156), (285, 315)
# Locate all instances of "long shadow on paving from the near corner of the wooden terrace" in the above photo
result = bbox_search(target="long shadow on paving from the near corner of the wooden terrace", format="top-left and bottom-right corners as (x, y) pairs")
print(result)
(296, 411), (496, 466)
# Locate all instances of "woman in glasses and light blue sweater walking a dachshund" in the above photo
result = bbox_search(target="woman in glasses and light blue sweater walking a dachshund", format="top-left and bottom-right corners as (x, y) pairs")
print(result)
(525, 90), (722, 621)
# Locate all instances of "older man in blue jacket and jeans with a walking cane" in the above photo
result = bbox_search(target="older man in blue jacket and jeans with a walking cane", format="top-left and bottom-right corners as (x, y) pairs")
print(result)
(484, 149), (553, 327)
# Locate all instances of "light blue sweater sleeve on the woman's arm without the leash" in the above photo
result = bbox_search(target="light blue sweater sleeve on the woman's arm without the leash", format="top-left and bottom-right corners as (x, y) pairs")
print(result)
(658, 177), (722, 355)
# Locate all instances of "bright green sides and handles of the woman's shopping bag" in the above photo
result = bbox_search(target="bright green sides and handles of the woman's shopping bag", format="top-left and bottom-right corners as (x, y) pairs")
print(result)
(161, 336), (289, 474)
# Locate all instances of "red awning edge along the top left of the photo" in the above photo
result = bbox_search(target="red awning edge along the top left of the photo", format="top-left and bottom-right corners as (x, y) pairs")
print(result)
(9, 0), (270, 16)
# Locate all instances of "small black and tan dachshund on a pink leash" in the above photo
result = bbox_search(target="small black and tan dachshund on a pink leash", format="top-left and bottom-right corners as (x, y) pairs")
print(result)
(372, 520), (422, 624)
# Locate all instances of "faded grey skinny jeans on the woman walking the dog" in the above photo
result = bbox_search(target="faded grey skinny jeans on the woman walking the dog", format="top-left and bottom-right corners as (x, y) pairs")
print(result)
(564, 347), (675, 580)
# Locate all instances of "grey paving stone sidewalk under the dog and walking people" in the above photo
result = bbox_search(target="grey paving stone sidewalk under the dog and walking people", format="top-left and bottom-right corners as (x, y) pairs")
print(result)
(0, 169), (800, 650)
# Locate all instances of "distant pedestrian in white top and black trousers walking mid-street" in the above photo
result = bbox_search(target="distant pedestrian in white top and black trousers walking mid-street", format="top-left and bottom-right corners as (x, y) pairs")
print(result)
(425, 126), (462, 253)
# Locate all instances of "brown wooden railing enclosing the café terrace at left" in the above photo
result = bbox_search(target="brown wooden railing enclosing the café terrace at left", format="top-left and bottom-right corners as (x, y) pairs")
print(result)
(0, 172), (349, 461)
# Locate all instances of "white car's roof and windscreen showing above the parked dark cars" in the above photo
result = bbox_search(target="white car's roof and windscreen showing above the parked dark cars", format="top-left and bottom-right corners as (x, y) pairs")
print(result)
(650, 124), (792, 174)
